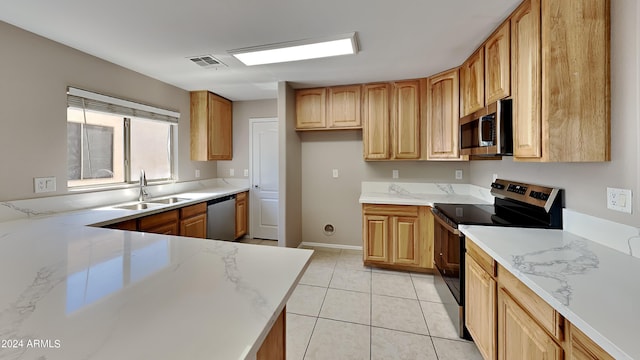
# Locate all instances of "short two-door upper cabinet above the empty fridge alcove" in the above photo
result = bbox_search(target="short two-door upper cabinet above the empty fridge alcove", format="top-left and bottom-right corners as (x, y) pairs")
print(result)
(296, 85), (362, 130)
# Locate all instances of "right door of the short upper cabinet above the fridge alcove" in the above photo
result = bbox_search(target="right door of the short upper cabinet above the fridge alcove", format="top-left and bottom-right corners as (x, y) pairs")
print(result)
(328, 85), (362, 128)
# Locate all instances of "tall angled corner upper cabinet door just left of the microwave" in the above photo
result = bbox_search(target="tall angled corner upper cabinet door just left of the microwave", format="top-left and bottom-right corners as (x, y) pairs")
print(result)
(426, 69), (460, 160)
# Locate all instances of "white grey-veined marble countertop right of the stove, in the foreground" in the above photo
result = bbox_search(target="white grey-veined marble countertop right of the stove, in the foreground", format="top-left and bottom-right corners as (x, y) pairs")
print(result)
(460, 225), (640, 359)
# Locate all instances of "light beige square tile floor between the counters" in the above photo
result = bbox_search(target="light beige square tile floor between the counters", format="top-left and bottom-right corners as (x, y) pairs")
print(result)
(287, 248), (481, 360)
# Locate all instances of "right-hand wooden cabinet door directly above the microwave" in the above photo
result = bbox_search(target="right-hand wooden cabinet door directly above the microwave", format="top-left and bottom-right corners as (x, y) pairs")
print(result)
(484, 20), (511, 105)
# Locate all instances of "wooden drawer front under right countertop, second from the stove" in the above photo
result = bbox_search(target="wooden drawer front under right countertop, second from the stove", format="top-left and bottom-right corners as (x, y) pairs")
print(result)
(498, 265), (564, 341)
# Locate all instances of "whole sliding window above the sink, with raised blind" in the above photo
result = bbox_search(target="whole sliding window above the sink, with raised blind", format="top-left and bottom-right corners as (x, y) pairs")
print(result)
(67, 88), (180, 188)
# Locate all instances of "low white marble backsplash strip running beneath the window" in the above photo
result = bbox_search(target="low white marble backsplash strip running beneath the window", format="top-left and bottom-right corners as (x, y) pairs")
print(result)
(0, 179), (248, 221)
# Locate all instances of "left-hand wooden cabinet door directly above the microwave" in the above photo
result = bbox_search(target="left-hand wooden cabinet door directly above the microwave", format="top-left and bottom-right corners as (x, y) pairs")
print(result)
(460, 47), (484, 116)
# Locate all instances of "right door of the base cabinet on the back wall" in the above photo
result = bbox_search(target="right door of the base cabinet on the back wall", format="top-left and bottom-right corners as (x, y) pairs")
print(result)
(391, 216), (420, 265)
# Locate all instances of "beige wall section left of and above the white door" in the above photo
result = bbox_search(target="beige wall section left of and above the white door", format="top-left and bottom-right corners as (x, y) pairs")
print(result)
(218, 99), (278, 179)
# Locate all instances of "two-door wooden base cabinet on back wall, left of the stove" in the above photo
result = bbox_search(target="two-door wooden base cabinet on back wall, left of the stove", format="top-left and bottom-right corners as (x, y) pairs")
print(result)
(362, 204), (433, 269)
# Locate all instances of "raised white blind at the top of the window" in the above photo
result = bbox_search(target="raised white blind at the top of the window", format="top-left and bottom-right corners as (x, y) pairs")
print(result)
(67, 87), (180, 124)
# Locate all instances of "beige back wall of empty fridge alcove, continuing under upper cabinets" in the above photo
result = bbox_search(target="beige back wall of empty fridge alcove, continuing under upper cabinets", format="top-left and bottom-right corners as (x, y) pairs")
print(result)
(300, 130), (469, 246)
